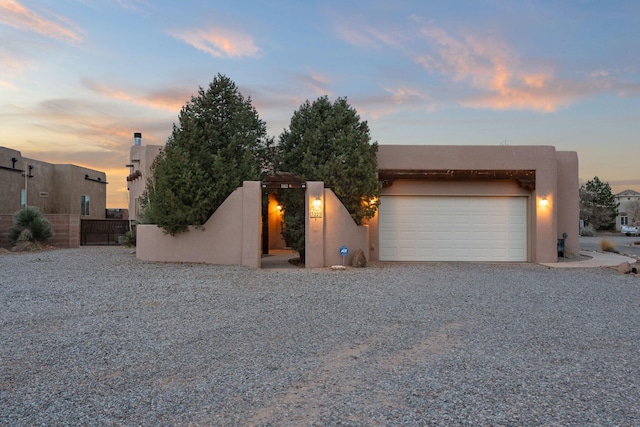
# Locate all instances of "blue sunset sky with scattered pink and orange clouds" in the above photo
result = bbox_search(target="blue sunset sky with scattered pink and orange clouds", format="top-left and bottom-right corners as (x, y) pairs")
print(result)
(0, 0), (640, 208)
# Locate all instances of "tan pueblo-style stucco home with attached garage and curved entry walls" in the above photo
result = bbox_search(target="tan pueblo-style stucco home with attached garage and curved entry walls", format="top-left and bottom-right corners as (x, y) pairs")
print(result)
(129, 140), (579, 268)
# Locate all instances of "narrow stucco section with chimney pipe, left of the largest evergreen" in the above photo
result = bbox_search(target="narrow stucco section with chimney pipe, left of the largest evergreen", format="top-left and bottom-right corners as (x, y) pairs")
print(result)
(126, 132), (163, 220)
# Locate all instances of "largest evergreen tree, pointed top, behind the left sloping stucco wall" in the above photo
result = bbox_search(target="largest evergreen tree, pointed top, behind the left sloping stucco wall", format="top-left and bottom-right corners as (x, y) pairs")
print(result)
(143, 74), (273, 234)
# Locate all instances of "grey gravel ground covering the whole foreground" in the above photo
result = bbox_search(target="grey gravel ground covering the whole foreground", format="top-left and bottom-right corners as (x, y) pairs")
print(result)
(0, 247), (640, 426)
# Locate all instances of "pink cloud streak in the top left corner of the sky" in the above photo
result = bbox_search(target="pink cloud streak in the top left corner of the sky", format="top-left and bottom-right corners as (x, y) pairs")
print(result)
(0, 0), (82, 43)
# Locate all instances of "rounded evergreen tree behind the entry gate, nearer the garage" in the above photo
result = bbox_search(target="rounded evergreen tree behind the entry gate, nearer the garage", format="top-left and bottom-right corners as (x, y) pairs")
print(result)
(278, 96), (380, 256)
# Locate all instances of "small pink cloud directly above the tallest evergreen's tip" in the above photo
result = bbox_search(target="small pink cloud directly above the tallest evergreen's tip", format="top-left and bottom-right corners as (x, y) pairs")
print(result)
(172, 27), (260, 58)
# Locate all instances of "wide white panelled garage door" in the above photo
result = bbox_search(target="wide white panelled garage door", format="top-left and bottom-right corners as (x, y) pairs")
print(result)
(378, 196), (527, 261)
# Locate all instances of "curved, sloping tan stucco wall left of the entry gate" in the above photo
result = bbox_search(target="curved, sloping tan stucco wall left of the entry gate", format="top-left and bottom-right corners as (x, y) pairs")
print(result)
(136, 181), (262, 268)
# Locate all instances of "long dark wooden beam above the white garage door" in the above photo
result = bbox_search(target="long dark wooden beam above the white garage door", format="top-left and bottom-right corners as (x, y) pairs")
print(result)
(378, 169), (536, 190)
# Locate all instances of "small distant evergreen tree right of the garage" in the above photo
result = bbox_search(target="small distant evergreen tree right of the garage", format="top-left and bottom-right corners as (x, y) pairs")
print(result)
(579, 176), (620, 230)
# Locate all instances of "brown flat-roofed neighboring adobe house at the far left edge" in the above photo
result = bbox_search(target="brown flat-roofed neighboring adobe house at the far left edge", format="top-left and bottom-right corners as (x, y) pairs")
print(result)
(0, 147), (107, 219)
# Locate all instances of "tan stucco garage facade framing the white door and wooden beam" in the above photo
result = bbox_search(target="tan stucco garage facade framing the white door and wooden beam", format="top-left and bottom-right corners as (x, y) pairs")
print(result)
(370, 145), (579, 262)
